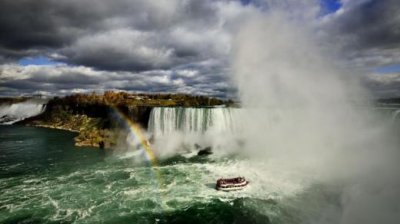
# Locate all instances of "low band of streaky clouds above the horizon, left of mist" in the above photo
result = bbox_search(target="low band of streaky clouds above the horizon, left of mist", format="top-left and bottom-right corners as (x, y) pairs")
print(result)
(0, 65), (231, 97)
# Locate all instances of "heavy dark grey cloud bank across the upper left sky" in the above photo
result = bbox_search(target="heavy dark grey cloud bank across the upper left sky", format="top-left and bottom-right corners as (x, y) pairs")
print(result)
(0, 0), (238, 71)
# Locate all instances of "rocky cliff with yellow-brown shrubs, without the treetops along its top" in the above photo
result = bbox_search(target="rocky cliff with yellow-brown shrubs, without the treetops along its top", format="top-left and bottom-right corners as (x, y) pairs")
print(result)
(20, 99), (151, 148)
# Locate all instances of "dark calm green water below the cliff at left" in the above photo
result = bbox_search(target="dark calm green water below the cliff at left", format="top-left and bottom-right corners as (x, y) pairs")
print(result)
(0, 125), (106, 178)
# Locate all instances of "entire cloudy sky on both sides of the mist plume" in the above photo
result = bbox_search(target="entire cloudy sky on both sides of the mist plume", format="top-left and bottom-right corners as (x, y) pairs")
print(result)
(0, 0), (400, 97)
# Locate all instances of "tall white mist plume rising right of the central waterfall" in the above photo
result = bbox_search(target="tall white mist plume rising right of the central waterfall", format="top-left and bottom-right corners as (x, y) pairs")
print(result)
(233, 10), (400, 223)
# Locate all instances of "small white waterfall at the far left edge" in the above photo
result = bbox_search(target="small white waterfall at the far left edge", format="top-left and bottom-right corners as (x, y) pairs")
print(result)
(0, 100), (46, 124)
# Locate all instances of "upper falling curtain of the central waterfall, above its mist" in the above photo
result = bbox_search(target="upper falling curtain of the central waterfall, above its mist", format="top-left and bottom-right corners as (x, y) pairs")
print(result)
(148, 107), (240, 136)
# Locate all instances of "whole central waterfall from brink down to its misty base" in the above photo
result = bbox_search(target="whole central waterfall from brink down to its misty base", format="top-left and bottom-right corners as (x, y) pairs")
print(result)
(148, 107), (243, 157)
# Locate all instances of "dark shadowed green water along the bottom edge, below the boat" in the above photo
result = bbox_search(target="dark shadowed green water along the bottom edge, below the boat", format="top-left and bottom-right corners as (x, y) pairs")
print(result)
(3, 198), (275, 224)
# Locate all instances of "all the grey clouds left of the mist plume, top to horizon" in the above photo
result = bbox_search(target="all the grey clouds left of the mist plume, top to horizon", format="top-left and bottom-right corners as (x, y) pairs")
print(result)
(0, 0), (257, 96)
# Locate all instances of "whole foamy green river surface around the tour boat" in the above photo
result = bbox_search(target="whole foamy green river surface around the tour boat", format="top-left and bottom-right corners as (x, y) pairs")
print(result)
(0, 126), (340, 223)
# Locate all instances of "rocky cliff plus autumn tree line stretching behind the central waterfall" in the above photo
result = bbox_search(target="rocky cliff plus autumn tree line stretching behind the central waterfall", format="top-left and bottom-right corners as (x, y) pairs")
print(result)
(19, 92), (231, 149)
